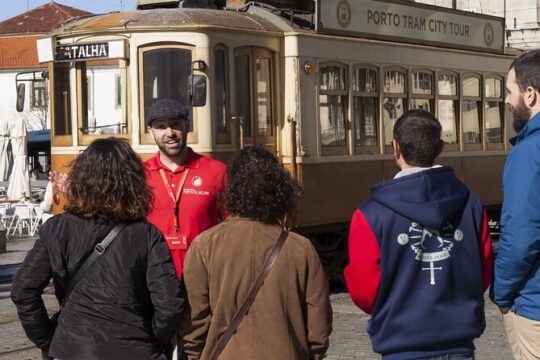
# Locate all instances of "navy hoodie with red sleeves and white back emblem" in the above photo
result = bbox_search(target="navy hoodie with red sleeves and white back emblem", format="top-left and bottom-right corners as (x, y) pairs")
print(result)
(345, 167), (493, 359)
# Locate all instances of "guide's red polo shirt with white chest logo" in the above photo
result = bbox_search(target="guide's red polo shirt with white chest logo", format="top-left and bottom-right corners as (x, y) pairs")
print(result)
(144, 148), (226, 278)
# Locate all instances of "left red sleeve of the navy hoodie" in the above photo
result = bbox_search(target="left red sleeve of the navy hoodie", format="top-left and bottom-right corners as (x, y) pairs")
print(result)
(345, 210), (381, 314)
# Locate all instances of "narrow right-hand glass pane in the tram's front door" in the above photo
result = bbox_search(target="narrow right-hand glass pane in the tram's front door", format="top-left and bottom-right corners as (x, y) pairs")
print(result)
(256, 58), (272, 136)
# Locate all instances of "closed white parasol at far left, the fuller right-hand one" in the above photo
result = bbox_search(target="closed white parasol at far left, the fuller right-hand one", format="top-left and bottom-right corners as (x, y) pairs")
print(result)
(7, 121), (31, 200)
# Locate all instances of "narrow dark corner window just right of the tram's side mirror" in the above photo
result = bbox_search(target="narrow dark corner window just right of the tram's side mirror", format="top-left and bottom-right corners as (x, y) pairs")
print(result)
(212, 44), (231, 145)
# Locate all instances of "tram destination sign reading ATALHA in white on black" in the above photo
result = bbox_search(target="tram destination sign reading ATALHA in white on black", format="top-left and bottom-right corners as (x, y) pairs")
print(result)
(54, 40), (125, 61)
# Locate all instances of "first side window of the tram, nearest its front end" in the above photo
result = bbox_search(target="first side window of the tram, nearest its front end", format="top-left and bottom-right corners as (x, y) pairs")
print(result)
(319, 65), (348, 155)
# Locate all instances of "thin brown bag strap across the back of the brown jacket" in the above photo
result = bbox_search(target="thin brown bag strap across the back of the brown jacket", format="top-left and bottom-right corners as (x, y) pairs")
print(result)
(210, 229), (289, 360)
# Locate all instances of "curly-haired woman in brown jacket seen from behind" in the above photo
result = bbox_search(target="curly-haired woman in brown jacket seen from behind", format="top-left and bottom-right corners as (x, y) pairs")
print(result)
(181, 147), (332, 360)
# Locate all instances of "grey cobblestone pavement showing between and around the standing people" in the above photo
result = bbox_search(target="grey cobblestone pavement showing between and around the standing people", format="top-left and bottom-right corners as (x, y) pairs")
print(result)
(0, 239), (512, 360)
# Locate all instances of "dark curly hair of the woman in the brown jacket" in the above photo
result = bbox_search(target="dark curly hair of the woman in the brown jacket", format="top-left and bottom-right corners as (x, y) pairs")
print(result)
(225, 146), (301, 226)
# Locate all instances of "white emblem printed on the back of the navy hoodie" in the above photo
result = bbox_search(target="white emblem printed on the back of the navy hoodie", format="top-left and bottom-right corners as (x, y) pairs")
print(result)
(397, 222), (463, 285)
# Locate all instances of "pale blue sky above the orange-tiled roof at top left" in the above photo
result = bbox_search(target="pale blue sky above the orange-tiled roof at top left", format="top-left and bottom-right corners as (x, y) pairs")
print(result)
(0, 0), (136, 21)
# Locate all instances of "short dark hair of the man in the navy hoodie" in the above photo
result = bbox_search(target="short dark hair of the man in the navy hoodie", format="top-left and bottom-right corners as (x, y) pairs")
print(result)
(394, 109), (442, 167)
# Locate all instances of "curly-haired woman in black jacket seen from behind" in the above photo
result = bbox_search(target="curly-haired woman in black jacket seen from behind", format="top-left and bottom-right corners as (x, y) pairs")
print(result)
(11, 138), (185, 360)
